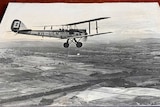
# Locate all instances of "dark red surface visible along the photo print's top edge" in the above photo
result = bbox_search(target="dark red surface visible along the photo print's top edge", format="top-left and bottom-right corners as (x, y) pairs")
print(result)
(0, 0), (160, 21)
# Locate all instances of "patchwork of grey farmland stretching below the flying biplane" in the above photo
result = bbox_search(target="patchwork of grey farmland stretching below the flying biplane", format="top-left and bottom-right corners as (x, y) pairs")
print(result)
(0, 38), (160, 106)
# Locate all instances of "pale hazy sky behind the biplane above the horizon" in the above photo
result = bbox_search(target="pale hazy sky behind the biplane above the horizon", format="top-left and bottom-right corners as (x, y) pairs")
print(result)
(0, 2), (160, 41)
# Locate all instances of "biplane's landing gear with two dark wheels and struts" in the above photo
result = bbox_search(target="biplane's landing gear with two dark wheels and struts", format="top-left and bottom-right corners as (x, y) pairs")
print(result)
(63, 38), (83, 48)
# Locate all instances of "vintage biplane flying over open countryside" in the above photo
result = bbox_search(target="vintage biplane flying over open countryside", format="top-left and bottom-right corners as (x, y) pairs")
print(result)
(11, 17), (112, 48)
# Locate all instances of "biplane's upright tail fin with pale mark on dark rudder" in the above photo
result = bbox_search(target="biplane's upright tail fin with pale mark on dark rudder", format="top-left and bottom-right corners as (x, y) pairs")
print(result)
(11, 19), (27, 32)
